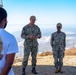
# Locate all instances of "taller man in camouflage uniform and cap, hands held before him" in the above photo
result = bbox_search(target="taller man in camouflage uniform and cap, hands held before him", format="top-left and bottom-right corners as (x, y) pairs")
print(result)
(21, 16), (41, 75)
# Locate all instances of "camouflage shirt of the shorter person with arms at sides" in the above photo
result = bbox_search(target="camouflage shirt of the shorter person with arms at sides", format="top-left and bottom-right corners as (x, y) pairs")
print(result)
(51, 32), (66, 50)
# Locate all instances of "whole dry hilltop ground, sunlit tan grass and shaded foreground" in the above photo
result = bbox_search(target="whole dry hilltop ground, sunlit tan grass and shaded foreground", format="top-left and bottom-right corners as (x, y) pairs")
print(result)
(13, 49), (76, 75)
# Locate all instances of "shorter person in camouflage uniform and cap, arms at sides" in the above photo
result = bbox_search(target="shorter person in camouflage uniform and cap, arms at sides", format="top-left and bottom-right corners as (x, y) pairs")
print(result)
(51, 23), (66, 73)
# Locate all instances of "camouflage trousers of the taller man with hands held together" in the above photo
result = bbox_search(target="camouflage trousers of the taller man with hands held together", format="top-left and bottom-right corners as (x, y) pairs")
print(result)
(22, 46), (38, 68)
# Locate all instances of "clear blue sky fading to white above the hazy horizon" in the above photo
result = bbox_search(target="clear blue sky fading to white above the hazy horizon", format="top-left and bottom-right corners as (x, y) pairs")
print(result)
(3, 0), (76, 24)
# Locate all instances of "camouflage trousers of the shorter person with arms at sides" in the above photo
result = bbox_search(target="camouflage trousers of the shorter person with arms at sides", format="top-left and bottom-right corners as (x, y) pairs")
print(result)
(53, 50), (64, 68)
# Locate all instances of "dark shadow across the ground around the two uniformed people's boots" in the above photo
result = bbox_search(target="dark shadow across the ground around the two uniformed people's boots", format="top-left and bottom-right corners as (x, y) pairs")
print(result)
(13, 65), (76, 75)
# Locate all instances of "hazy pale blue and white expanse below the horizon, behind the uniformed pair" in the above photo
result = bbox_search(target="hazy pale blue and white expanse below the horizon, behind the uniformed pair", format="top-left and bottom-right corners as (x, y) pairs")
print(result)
(6, 24), (76, 57)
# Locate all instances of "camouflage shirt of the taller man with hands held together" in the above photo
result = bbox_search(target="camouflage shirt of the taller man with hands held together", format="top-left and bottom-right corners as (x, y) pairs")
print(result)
(21, 24), (41, 47)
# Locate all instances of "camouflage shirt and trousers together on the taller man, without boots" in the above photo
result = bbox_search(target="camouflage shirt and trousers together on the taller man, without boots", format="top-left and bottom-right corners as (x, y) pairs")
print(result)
(21, 24), (41, 68)
